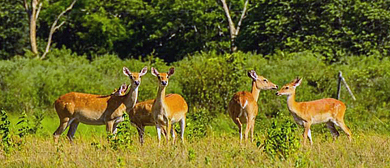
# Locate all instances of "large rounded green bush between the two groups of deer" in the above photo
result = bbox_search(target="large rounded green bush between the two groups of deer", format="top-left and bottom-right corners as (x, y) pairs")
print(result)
(176, 53), (246, 115)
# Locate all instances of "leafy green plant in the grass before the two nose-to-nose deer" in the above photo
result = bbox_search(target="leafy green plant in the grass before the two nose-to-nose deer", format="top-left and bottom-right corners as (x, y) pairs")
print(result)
(264, 119), (300, 159)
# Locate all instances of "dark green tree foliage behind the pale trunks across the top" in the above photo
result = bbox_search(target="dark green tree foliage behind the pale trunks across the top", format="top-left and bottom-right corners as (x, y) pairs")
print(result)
(0, 0), (390, 62)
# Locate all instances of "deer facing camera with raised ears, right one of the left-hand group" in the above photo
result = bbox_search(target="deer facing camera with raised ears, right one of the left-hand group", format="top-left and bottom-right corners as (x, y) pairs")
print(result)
(151, 67), (188, 144)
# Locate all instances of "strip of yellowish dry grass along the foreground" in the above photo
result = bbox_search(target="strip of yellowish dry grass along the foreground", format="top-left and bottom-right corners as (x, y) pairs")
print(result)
(0, 114), (390, 167)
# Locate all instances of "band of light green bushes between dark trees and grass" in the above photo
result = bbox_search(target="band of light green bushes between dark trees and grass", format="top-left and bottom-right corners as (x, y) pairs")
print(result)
(0, 49), (390, 135)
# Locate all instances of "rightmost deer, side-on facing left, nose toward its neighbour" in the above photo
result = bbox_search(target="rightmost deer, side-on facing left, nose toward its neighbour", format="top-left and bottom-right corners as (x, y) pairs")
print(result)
(276, 77), (352, 145)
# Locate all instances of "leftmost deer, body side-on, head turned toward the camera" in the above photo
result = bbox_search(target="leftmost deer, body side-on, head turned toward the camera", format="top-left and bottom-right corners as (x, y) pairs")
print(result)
(53, 67), (147, 143)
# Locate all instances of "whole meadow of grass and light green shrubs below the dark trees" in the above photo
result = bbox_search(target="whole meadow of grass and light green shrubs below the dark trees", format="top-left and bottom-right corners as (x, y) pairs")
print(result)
(0, 49), (390, 167)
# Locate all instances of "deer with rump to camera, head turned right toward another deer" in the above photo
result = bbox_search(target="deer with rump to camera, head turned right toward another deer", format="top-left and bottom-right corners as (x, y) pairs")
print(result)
(228, 70), (278, 142)
